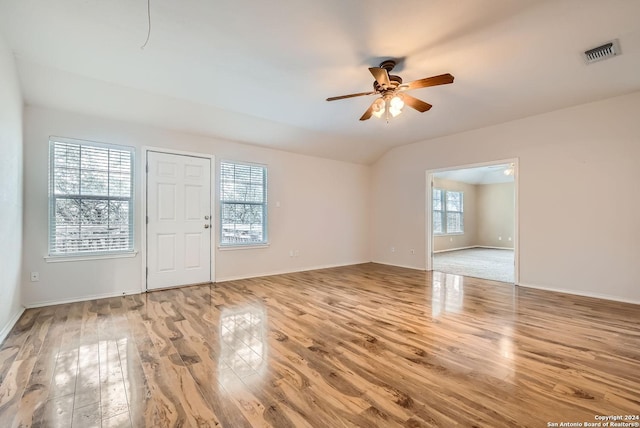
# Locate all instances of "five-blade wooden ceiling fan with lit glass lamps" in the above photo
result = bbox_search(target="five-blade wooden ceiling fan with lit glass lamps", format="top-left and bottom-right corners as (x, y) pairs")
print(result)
(327, 59), (453, 122)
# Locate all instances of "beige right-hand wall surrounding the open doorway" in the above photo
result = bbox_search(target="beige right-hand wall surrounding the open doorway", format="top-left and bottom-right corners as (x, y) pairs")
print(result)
(371, 92), (640, 303)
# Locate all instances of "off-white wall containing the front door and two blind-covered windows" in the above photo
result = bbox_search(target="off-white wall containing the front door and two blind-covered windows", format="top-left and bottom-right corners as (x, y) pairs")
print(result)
(22, 107), (370, 306)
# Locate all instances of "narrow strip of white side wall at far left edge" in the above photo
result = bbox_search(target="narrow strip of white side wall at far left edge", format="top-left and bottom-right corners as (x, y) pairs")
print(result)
(0, 36), (23, 342)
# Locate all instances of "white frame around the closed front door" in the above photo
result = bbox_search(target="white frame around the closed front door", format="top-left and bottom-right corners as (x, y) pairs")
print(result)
(140, 146), (218, 293)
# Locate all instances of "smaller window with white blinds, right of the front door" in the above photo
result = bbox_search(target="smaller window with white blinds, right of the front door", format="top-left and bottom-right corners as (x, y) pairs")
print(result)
(220, 161), (267, 246)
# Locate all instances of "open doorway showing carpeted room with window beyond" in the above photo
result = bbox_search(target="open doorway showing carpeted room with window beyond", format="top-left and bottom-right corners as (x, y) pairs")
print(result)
(426, 158), (519, 284)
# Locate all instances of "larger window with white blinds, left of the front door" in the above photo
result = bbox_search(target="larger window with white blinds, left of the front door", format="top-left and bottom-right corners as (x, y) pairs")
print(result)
(49, 138), (133, 256)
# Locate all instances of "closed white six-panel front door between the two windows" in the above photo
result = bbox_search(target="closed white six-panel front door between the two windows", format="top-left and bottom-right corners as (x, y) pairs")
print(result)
(147, 151), (212, 290)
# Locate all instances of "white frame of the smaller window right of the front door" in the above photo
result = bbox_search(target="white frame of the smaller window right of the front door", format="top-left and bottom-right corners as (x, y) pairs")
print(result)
(218, 159), (269, 250)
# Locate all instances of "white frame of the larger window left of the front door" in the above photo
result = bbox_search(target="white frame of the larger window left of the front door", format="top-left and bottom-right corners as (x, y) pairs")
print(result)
(45, 136), (137, 261)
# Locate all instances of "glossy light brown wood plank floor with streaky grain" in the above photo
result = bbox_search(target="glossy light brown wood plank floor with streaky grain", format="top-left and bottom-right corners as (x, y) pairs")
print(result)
(0, 264), (640, 428)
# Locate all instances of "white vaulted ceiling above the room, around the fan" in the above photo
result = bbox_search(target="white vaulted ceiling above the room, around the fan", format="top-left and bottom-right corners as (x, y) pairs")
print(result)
(0, 0), (640, 163)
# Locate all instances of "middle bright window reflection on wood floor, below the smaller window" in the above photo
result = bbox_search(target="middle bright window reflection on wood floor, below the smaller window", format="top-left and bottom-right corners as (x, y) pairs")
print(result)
(218, 306), (267, 390)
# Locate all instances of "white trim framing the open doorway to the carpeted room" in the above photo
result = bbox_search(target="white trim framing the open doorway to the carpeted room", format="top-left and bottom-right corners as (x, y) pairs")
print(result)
(425, 158), (520, 285)
